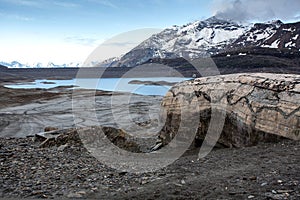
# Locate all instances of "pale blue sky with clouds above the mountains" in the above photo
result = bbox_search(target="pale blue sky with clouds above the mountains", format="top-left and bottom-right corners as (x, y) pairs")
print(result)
(0, 0), (300, 64)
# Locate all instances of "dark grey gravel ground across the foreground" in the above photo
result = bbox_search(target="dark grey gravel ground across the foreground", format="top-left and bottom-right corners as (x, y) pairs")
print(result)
(0, 138), (300, 199)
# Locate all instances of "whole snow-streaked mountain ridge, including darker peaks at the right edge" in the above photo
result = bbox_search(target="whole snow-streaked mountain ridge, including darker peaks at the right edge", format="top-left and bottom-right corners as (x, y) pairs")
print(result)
(110, 17), (300, 67)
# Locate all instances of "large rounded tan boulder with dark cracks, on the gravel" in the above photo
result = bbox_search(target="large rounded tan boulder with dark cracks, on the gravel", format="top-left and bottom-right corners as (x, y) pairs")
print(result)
(159, 73), (300, 147)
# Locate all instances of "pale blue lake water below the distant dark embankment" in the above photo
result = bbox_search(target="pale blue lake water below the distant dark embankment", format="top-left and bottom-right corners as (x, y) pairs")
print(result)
(5, 77), (190, 96)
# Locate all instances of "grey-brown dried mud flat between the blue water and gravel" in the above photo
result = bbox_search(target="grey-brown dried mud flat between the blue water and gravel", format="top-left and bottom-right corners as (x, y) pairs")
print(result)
(0, 86), (162, 137)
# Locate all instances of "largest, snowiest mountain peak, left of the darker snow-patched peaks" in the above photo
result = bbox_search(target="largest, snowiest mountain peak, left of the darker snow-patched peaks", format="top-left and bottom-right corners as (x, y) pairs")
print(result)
(112, 17), (250, 67)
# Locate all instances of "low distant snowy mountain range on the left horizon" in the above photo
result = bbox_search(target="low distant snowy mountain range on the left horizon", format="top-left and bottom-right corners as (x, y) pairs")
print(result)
(0, 61), (82, 68)
